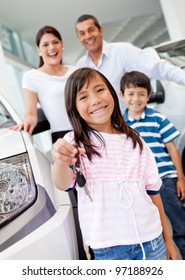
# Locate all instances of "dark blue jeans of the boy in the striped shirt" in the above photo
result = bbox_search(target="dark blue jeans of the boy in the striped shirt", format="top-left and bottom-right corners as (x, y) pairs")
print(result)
(160, 178), (185, 260)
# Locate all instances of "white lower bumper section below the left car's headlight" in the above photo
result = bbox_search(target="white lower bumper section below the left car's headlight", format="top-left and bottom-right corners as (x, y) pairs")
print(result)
(0, 205), (78, 260)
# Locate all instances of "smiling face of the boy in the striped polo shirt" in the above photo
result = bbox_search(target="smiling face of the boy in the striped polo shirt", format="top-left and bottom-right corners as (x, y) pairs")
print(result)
(121, 84), (150, 118)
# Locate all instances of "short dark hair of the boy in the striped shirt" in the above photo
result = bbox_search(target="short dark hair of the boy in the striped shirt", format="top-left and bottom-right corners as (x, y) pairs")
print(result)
(120, 71), (151, 94)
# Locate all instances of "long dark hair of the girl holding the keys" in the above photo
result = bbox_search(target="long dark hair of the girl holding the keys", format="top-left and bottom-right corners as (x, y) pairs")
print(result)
(65, 67), (143, 160)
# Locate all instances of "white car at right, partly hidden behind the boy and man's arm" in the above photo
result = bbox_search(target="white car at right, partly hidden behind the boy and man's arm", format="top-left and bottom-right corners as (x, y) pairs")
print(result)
(149, 40), (185, 173)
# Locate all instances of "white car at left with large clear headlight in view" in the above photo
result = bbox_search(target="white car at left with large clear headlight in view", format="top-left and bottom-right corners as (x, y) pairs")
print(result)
(0, 95), (79, 260)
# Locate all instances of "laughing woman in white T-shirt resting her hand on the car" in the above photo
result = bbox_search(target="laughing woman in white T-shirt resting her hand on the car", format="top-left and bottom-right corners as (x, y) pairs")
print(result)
(11, 26), (75, 143)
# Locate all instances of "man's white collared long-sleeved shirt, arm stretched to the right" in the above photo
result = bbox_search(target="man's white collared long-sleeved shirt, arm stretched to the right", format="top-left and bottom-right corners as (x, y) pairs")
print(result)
(77, 41), (185, 109)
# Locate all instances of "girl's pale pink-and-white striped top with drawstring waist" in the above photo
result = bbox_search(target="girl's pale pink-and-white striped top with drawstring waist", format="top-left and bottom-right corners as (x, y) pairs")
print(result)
(64, 132), (162, 248)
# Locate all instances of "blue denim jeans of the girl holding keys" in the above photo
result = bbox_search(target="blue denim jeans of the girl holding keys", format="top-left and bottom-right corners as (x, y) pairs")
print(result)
(93, 235), (166, 260)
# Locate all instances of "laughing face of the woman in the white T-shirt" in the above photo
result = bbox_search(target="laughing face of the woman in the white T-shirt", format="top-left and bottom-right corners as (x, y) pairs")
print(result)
(38, 33), (63, 65)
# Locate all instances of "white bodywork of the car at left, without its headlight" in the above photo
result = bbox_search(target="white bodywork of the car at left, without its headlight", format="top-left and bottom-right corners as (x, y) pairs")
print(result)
(0, 95), (79, 260)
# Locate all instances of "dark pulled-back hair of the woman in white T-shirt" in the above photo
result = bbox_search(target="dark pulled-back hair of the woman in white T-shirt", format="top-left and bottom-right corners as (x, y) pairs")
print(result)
(35, 25), (62, 67)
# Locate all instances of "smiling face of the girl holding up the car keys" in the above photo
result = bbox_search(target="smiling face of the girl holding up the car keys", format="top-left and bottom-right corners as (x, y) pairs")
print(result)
(76, 75), (114, 133)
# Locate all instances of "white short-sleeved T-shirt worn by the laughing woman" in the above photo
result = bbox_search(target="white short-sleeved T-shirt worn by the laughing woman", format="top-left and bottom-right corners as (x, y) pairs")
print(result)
(22, 65), (76, 132)
